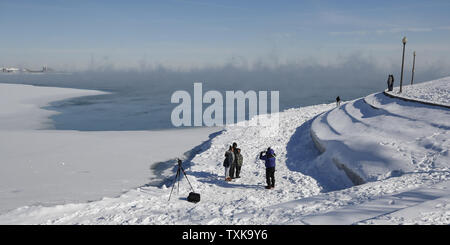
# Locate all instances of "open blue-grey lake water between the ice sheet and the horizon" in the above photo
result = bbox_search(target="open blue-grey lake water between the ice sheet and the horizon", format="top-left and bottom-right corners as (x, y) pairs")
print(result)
(0, 70), (385, 131)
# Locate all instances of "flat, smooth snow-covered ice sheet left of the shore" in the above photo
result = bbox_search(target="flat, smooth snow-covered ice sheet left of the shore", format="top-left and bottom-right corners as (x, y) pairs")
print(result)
(0, 84), (218, 213)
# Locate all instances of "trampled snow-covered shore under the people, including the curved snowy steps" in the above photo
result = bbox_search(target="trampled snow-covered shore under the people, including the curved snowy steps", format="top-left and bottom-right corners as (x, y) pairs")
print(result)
(0, 77), (450, 224)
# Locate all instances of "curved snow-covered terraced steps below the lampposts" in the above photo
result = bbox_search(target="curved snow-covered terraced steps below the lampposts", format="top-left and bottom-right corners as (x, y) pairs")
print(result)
(311, 93), (450, 184)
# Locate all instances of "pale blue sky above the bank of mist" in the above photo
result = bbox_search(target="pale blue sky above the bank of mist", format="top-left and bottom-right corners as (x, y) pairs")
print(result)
(0, 0), (450, 70)
